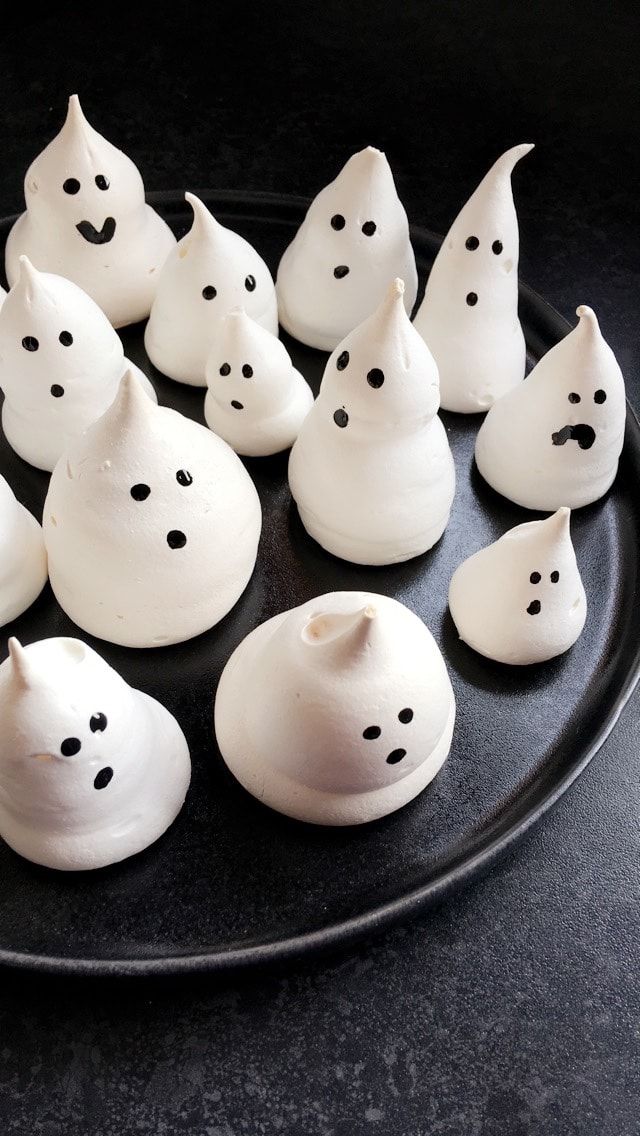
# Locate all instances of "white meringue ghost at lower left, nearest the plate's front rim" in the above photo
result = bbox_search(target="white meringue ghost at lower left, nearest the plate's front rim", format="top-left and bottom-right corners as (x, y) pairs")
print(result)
(0, 638), (191, 871)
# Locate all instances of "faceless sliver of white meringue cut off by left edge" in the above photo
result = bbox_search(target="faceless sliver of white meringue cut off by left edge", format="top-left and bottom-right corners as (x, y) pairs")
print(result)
(0, 475), (47, 626)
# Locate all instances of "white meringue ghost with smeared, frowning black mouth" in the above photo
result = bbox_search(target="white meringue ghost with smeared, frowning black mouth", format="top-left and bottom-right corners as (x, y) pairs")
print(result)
(475, 304), (626, 510)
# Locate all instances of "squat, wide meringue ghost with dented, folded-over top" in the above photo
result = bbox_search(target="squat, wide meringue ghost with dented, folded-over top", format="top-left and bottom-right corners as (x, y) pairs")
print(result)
(215, 592), (456, 825)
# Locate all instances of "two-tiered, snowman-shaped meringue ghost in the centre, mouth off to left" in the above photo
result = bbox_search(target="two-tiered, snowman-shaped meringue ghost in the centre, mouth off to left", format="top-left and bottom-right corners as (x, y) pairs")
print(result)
(289, 279), (455, 565)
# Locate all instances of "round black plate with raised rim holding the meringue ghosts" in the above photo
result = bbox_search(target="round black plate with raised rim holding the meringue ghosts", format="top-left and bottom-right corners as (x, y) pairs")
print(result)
(0, 193), (640, 975)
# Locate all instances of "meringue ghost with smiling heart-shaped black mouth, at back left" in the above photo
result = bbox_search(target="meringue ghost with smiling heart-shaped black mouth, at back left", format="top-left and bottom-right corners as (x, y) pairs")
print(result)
(6, 94), (175, 327)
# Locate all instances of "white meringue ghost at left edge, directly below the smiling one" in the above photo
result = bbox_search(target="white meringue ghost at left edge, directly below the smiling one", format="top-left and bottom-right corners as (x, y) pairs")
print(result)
(0, 257), (156, 473)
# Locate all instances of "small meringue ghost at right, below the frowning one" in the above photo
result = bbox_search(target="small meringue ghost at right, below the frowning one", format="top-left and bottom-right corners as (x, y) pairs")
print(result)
(449, 507), (587, 666)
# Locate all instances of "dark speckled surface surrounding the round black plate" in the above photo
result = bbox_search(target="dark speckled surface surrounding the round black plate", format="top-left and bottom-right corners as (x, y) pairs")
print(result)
(0, 0), (640, 1136)
